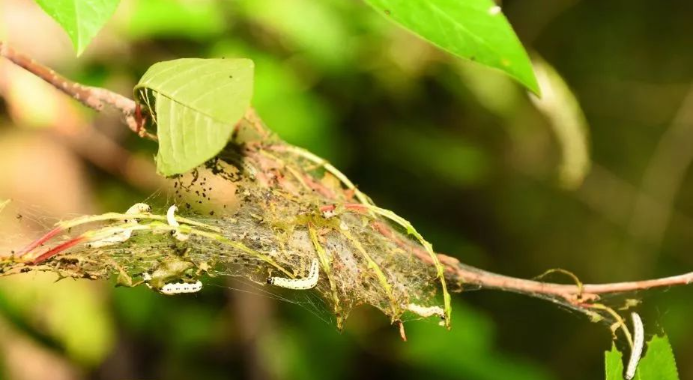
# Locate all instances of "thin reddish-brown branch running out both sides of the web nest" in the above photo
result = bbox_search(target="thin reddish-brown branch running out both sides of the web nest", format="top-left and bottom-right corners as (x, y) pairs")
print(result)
(0, 42), (693, 314)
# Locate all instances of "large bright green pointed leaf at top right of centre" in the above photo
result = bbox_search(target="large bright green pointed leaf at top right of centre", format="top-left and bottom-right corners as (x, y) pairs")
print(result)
(366, 0), (540, 95)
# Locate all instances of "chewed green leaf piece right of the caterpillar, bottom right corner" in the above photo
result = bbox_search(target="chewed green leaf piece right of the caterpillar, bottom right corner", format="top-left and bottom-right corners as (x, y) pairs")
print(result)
(635, 335), (679, 380)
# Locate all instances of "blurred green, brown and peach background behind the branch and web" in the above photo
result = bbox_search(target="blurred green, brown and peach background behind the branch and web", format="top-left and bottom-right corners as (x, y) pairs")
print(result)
(0, 0), (693, 380)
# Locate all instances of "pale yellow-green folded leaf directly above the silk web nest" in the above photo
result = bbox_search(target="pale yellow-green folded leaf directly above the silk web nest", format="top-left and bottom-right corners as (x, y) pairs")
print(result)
(135, 58), (253, 176)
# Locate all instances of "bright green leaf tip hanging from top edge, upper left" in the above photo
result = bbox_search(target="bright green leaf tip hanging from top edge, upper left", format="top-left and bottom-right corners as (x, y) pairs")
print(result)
(36, 0), (120, 55)
